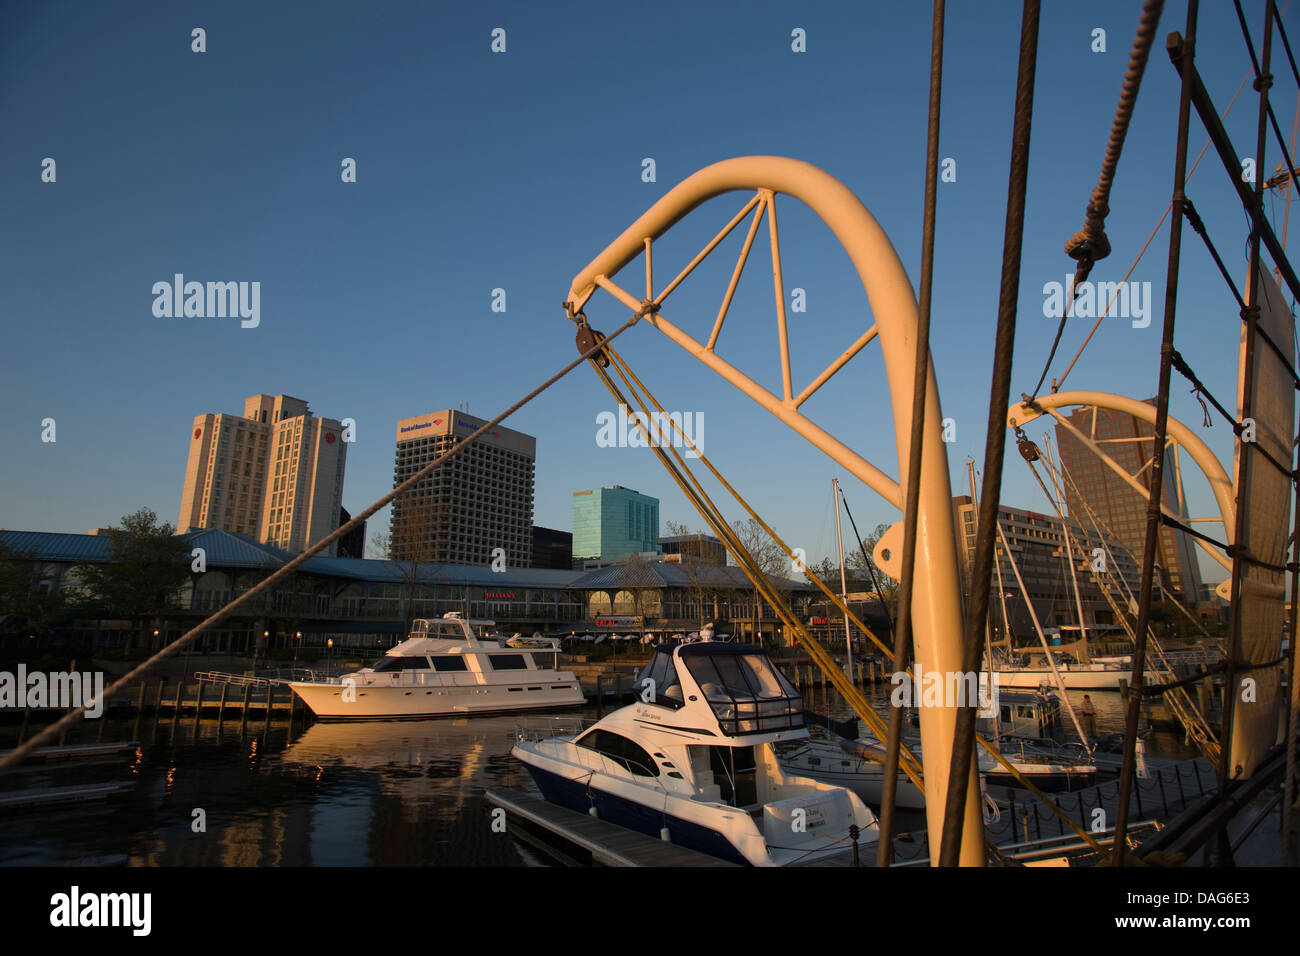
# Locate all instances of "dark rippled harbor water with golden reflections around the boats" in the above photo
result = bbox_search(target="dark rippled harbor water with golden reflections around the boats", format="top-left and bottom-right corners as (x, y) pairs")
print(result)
(0, 688), (1193, 866)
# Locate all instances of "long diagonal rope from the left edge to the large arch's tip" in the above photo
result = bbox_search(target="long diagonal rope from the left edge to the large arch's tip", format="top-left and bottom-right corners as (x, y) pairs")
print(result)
(0, 310), (645, 770)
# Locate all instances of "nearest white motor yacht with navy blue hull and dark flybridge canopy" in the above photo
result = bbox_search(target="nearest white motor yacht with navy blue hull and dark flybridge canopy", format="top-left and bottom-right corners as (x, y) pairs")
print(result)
(514, 640), (879, 866)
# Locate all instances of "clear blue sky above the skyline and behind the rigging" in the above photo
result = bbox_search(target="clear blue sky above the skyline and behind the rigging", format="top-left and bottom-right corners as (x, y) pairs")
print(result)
(0, 0), (1300, 582)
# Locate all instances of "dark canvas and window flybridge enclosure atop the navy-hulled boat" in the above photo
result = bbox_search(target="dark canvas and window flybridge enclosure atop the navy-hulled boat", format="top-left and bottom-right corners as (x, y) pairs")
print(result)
(681, 645), (803, 736)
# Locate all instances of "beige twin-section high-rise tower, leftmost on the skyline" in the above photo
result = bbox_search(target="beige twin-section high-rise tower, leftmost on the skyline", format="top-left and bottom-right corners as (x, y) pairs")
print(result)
(177, 395), (347, 554)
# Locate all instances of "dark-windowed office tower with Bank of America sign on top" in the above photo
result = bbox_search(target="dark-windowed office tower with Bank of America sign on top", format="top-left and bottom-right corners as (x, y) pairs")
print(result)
(390, 411), (537, 568)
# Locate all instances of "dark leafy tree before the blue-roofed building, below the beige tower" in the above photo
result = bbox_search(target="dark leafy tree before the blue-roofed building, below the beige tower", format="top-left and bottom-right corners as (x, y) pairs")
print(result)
(77, 507), (190, 655)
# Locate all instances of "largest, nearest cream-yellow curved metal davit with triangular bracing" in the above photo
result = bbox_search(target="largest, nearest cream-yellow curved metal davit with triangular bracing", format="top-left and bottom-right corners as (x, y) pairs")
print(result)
(568, 156), (984, 865)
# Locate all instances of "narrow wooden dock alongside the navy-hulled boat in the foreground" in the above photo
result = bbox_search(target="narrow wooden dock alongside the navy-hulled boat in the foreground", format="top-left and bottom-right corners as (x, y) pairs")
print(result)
(486, 787), (735, 866)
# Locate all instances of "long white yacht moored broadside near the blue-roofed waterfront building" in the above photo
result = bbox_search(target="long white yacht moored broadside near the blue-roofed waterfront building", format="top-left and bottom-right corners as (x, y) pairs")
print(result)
(286, 613), (586, 719)
